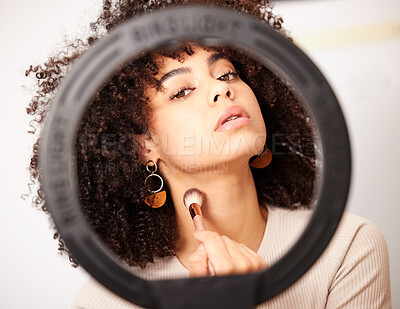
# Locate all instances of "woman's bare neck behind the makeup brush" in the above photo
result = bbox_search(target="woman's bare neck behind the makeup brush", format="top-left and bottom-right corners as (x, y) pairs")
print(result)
(162, 159), (268, 264)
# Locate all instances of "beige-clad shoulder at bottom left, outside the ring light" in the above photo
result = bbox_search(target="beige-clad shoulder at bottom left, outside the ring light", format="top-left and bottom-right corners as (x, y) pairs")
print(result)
(71, 277), (143, 309)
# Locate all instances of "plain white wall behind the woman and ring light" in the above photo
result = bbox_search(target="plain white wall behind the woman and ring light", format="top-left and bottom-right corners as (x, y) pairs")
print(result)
(0, 0), (400, 309)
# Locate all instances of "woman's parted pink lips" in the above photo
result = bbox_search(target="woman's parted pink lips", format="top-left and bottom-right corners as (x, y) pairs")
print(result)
(214, 105), (250, 131)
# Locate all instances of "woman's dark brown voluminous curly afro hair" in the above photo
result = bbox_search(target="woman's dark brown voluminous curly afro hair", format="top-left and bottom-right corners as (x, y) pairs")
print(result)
(26, 0), (315, 268)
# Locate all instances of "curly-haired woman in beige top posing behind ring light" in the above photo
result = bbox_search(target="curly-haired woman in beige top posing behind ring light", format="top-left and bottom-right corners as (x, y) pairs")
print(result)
(28, 1), (390, 308)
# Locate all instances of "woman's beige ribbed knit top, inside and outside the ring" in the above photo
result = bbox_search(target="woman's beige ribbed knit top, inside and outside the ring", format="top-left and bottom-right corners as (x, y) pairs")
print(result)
(72, 206), (392, 309)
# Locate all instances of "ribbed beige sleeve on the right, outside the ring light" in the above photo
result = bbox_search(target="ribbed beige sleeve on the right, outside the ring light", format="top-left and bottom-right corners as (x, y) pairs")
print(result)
(323, 212), (391, 308)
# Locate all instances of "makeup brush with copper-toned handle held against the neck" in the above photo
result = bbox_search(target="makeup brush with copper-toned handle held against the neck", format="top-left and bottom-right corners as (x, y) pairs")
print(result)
(183, 188), (215, 276)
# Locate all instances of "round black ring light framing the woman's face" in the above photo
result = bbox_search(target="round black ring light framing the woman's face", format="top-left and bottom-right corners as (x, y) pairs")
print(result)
(40, 6), (351, 309)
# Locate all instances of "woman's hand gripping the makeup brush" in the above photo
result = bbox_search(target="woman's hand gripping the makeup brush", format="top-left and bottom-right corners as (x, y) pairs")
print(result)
(188, 231), (267, 277)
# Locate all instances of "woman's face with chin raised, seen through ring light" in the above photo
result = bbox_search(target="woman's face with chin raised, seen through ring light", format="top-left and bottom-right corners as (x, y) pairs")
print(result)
(145, 45), (266, 172)
